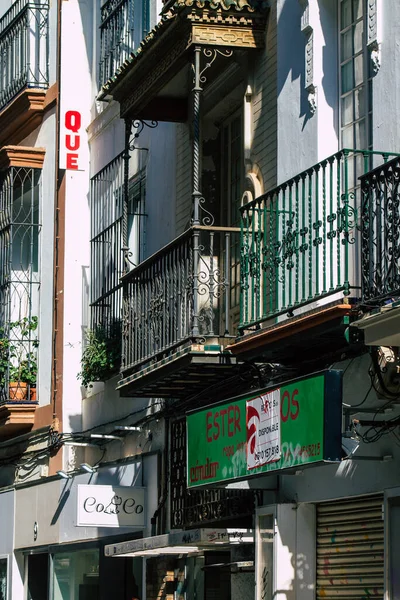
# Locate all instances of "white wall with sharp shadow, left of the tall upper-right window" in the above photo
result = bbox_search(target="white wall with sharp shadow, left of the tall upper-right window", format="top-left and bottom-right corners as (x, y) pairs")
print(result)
(277, 0), (339, 183)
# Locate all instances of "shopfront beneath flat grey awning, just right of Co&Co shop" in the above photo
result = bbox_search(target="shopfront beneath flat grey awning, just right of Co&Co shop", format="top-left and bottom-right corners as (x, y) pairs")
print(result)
(105, 528), (254, 600)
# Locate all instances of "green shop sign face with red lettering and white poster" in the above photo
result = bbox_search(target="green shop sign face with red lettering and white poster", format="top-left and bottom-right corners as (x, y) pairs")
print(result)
(186, 371), (342, 488)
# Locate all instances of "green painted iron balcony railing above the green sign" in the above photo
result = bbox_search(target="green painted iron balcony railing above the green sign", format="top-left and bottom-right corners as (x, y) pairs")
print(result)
(240, 149), (394, 331)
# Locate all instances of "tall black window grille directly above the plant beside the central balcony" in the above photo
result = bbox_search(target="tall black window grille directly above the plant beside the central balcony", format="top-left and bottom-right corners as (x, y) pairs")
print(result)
(90, 153), (146, 346)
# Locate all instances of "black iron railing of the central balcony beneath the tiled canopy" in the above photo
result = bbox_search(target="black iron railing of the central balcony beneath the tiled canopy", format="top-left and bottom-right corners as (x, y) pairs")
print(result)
(122, 226), (239, 372)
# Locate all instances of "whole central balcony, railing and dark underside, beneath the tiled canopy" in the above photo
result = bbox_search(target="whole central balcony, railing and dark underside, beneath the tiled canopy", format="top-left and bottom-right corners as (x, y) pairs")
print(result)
(118, 226), (239, 398)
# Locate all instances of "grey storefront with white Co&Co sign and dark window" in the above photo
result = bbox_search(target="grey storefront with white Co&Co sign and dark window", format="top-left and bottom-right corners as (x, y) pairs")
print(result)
(15, 454), (159, 600)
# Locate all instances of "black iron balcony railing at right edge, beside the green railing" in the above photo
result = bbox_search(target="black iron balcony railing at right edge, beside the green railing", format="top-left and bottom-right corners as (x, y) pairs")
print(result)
(361, 157), (400, 304)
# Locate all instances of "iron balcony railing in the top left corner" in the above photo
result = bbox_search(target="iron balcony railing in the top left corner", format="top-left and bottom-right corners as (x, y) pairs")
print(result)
(0, 0), (49, 110)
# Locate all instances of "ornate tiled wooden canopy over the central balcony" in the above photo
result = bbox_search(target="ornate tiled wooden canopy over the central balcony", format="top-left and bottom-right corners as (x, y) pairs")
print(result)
(99, 0), (267, 122)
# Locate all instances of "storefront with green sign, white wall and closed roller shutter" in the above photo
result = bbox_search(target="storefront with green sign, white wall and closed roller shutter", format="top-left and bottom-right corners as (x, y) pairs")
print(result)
(187, 371), (400, 600)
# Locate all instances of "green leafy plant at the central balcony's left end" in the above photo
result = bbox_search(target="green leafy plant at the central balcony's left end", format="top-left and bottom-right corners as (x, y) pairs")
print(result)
(77, 322), (121, 387)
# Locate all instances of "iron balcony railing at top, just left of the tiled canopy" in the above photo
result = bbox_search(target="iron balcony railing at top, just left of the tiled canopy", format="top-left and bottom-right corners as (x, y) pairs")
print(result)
(99, 0), (135, 87)
